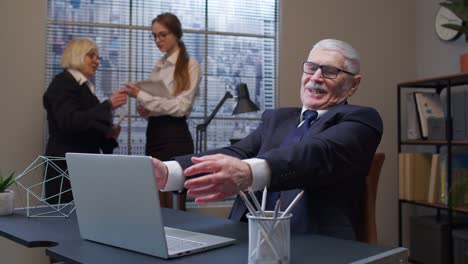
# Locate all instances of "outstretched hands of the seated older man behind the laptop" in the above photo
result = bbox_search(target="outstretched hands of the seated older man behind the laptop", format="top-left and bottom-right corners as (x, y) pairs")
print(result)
(153, 154), (253, 203)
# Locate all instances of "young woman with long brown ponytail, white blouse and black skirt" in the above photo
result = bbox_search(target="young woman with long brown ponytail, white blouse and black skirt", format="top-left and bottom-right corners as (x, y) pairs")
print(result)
(125, 13), (201, 209)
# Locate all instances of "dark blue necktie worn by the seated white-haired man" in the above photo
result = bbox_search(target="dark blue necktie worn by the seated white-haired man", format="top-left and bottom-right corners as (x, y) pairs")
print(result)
(265, 110), (318, 210)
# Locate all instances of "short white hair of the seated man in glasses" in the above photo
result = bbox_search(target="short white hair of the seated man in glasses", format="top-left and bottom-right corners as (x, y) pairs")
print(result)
(312, 39), (361, 74)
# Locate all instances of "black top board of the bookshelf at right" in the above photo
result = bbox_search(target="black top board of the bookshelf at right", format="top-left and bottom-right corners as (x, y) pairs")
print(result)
(398, 73), (468, 89)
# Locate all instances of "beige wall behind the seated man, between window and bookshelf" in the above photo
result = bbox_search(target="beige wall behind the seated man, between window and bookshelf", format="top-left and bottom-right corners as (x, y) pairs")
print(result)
(279, 0), (414, 245)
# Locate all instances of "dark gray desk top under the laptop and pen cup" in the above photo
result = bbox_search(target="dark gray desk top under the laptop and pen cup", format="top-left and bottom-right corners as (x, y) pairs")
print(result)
(0, 209), (407, 264)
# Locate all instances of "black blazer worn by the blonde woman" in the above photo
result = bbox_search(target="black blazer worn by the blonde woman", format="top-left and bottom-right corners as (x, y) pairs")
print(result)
(43, 70), (118, 157)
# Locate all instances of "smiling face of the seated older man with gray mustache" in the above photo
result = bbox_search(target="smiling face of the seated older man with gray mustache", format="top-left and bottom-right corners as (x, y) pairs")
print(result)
(301, 49), (361, 110)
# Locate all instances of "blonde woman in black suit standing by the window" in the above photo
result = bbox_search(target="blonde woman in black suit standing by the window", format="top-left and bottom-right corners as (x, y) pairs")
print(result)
(43, 39), (127, 203)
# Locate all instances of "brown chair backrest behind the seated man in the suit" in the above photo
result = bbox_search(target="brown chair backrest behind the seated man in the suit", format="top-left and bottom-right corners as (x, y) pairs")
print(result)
(356, 153), (385, 244)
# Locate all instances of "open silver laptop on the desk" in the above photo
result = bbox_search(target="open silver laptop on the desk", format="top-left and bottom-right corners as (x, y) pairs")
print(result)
(66, 153), (235, 258)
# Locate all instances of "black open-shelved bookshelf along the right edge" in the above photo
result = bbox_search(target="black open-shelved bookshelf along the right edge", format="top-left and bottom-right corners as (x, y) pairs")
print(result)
(397, 74), (468, 263)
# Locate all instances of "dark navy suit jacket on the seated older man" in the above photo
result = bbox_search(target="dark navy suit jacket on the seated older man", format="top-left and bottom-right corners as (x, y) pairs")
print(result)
(176, 104), (383, 239)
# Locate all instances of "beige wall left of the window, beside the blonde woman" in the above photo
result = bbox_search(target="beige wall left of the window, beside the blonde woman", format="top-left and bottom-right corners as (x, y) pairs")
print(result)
(0, 0), (48, 263)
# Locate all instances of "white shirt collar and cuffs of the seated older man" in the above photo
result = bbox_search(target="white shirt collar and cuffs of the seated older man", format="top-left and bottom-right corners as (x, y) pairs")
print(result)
(162, 107), (329, 191)
